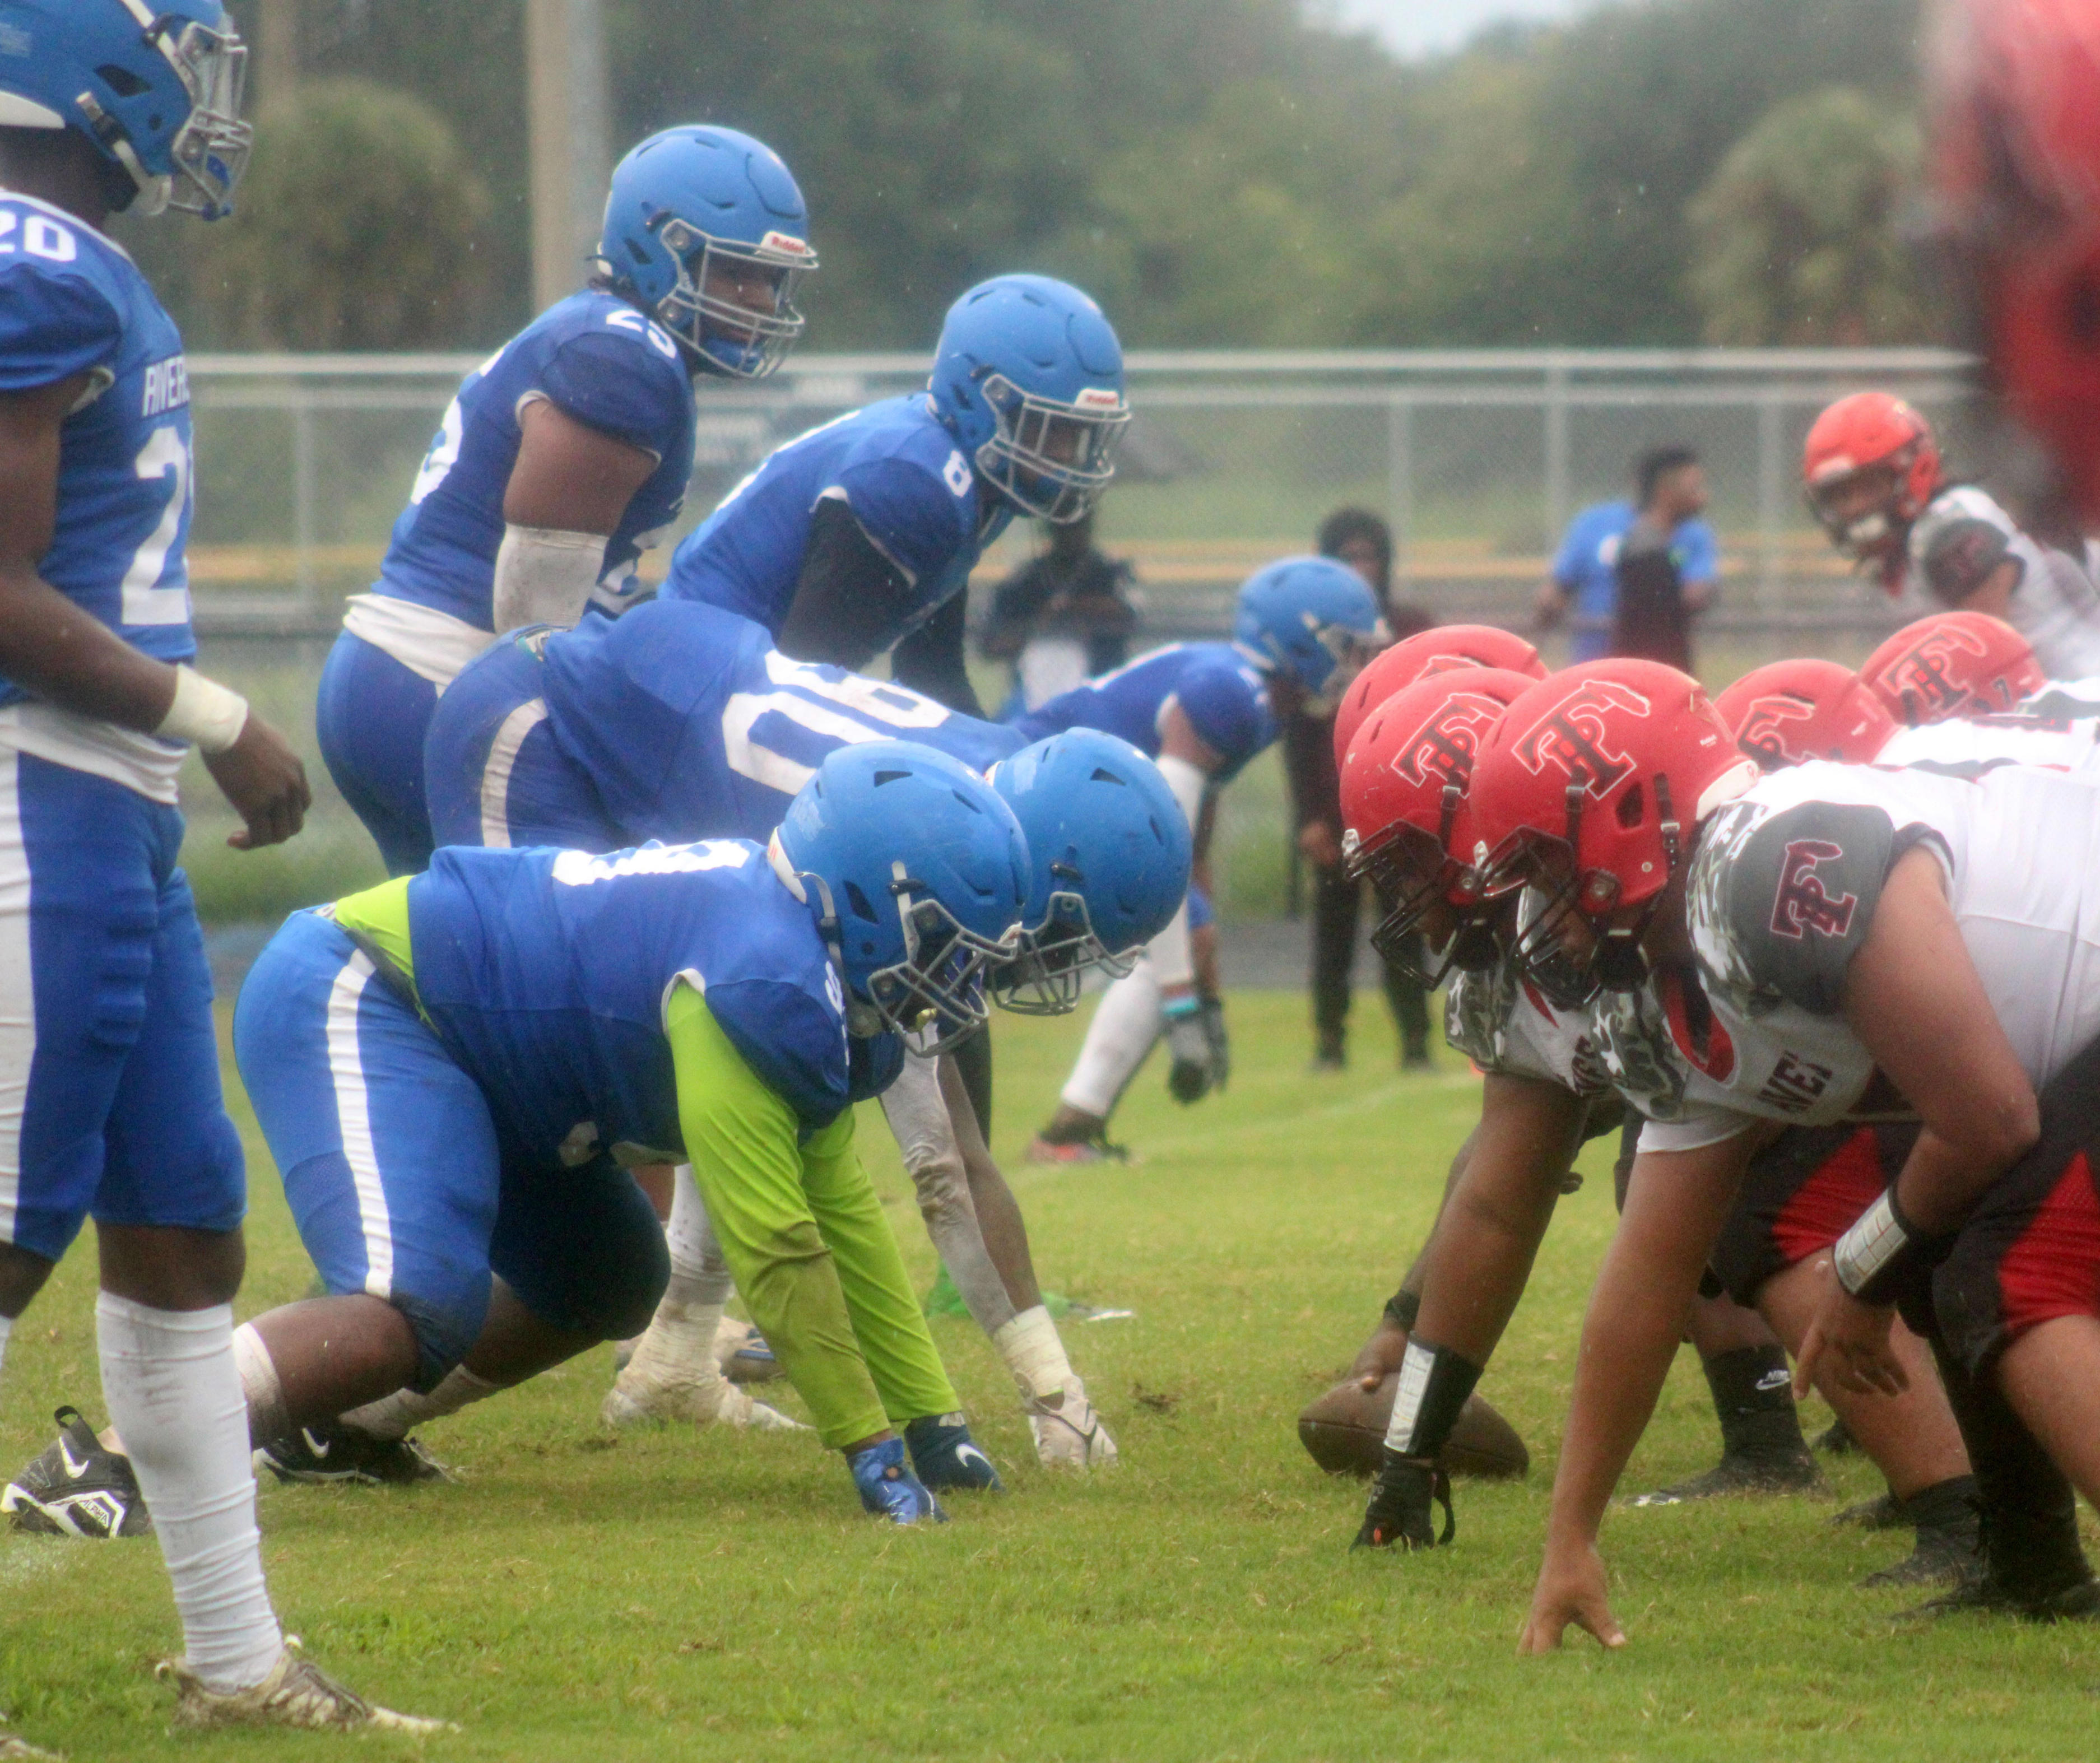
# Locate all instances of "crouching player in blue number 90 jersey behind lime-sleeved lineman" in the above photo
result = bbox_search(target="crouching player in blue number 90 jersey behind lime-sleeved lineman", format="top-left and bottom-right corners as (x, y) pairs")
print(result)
(426, 600), (1188, 1463)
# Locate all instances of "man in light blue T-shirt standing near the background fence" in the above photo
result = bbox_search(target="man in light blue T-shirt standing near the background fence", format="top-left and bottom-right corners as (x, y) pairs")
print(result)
(1537, 447), (1720, 672)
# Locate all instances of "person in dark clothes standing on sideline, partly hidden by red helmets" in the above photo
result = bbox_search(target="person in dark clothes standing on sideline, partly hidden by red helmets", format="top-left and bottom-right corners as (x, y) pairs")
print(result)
(1283, 508), (1434, 1071)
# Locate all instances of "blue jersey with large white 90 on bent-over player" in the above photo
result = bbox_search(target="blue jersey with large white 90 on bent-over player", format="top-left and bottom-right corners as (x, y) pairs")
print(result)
(533, 600), (1027, 844)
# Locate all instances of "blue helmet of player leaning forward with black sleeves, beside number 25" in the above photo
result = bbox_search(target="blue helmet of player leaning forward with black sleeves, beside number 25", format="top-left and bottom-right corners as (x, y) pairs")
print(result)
(928, 275), (1130, 525)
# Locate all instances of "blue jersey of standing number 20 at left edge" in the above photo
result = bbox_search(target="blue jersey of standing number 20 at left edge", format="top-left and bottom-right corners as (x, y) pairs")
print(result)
(0, 191), (197, 703)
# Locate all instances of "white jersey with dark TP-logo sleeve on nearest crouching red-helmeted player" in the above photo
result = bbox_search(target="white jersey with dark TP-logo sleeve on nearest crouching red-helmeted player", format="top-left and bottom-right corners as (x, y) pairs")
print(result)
(1629, 762), (2100, 1150)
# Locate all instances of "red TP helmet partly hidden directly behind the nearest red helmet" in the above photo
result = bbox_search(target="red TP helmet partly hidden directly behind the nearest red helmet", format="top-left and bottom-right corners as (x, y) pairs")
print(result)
(1342, 667), (1533, 987)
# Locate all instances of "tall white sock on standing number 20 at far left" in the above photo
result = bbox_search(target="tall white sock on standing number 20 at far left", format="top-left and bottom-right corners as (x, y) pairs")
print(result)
(95, 1293), (284, 1690)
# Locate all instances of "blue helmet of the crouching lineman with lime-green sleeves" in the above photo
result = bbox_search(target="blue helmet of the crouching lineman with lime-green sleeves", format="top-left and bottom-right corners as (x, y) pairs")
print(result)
(773, 741), (1029, 1035)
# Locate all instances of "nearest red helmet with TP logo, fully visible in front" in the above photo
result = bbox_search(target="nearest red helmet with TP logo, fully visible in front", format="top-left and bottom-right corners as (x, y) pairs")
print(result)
(1468, 659), (1758, 1010)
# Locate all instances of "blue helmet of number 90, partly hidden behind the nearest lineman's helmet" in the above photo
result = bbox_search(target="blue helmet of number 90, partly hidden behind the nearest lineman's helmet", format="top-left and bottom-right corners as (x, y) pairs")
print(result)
(991, 728), (1191, 1016)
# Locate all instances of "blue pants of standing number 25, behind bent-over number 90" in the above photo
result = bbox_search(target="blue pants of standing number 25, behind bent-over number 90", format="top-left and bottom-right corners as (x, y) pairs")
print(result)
(313, 632), (437, 875)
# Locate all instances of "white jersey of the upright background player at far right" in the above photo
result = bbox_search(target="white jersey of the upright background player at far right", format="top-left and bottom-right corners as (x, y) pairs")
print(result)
(1903, 483), (2100, 680)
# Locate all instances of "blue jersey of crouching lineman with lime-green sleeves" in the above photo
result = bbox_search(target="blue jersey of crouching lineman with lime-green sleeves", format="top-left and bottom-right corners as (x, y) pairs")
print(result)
(407, 840), (903, 1142)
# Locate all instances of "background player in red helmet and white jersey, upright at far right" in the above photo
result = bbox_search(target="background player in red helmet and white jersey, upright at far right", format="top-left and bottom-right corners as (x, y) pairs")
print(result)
(1802, 393), (2100, 680)
